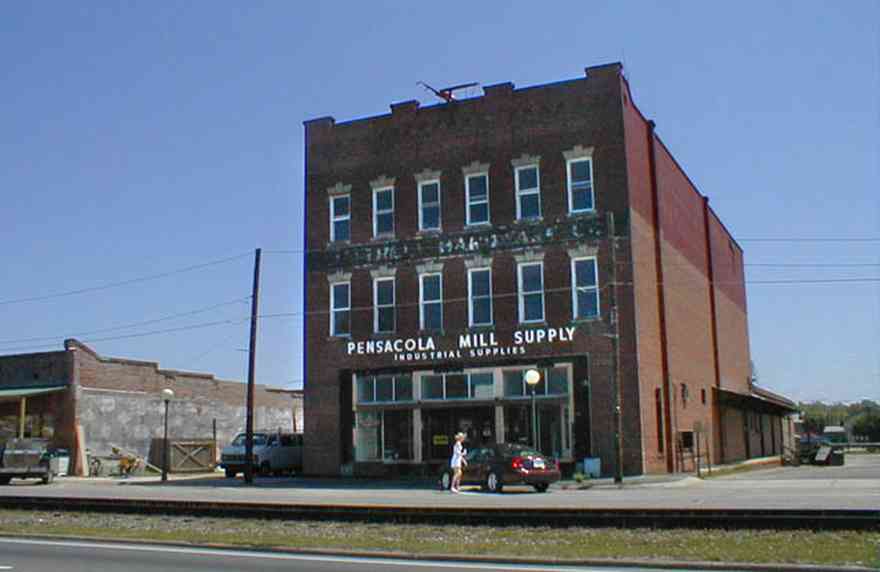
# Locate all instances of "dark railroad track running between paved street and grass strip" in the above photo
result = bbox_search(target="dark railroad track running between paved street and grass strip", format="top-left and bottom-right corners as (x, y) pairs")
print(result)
(0, 496), (880, 530)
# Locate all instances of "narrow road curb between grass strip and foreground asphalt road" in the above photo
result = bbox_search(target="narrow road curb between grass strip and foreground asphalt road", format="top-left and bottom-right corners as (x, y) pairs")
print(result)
(0, 534), (876, 572)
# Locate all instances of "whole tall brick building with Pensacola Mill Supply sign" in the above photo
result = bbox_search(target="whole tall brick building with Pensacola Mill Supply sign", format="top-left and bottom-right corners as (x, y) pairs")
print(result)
(304, 64), (791, 475)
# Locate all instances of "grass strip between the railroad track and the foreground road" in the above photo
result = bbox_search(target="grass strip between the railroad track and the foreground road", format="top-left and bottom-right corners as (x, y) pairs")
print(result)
(0, 510), (880, 567)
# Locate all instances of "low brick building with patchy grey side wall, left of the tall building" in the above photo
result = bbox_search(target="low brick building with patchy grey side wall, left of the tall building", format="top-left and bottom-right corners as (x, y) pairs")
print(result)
(0, 340), (303, 474)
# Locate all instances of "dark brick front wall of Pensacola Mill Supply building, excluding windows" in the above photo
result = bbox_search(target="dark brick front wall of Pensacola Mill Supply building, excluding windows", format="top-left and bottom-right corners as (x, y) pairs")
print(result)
(305, 66), (642, 474)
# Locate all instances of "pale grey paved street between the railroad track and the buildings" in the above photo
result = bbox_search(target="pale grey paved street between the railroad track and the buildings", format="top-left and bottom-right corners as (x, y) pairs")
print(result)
(0, 455), (880, 510)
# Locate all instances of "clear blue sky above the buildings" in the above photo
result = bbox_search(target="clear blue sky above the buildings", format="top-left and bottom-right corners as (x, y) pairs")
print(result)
(0, 0), (880, 400)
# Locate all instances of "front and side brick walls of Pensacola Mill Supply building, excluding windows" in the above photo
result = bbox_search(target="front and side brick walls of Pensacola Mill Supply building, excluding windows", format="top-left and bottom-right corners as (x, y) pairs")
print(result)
(303, 64), (796, 474)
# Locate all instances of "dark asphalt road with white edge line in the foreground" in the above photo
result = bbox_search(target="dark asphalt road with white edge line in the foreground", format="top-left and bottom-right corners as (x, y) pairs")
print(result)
(0, 538), (720, 572)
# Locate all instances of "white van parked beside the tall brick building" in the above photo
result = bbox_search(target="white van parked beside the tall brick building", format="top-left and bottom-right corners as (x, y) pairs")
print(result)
(220, 431), (303, 479)
